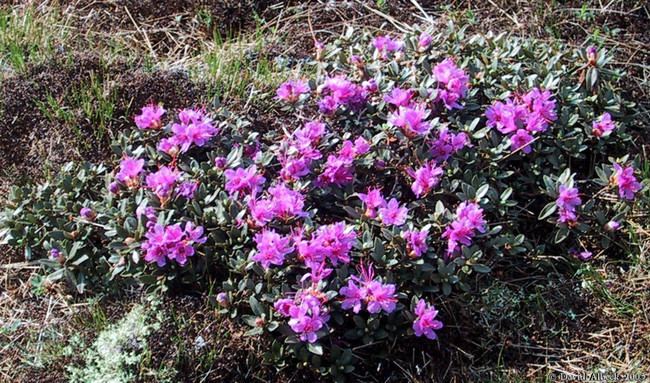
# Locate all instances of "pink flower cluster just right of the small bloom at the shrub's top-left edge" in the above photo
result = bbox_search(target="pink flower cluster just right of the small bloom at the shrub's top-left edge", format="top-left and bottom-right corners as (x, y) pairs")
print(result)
(318, 75), (368, 115)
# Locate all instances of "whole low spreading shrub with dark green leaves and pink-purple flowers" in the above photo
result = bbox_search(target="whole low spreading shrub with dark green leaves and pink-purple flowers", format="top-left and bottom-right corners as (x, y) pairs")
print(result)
(3, 24), (643, 377)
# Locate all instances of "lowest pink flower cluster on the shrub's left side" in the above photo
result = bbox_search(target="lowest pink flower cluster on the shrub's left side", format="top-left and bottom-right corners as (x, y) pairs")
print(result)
(141, 222), (206, 267)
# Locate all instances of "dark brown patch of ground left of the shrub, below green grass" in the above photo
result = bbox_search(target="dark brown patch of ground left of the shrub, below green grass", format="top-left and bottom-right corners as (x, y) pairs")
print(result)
(0, 54), (205, 191)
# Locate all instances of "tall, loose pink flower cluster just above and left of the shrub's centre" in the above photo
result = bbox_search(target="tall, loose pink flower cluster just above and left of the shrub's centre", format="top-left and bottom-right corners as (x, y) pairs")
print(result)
(278, 121), (326, 181)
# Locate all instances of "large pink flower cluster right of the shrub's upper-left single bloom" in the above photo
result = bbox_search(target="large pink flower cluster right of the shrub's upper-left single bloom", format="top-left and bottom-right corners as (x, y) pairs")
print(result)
(158, 109), (219, 157)
